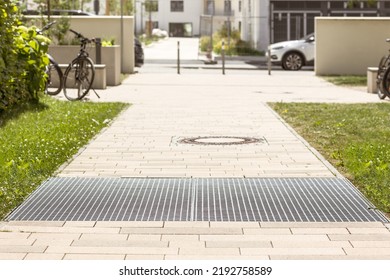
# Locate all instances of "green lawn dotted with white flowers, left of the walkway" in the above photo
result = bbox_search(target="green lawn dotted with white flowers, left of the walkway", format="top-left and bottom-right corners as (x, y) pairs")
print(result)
(0, 96), (128, 219)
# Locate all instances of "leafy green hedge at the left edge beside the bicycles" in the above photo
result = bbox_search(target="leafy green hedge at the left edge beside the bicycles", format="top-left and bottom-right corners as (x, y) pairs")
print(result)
(0, 0), (49, 111)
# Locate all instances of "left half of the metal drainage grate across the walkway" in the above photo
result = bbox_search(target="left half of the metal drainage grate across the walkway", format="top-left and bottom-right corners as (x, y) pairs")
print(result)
(8, 178), (191, 221)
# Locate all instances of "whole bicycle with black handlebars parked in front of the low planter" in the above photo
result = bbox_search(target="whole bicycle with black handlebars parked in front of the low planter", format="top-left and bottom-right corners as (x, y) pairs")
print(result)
(63, 29), (100, 101)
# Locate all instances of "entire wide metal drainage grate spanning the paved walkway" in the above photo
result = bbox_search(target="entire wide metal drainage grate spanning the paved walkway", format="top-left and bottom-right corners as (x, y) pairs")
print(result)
(7, 178), (388, 222)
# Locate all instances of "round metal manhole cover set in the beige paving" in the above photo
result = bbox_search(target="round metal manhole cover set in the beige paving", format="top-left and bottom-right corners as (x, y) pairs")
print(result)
(179, 136), (263, 145)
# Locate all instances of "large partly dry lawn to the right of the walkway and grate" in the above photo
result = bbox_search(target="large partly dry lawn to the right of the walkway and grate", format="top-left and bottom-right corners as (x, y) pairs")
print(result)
(271, 103), (390, 213)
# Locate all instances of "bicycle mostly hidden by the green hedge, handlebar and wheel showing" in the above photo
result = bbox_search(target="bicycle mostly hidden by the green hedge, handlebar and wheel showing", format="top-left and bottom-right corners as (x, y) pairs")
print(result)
(37, 21), (63, 95)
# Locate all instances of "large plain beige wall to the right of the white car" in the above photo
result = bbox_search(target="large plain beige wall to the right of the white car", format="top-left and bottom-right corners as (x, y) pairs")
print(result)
(315, 17), (390, 75)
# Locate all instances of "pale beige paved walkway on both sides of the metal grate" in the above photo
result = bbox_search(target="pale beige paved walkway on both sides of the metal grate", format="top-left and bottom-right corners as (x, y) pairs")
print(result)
(0, 44), (390, 260)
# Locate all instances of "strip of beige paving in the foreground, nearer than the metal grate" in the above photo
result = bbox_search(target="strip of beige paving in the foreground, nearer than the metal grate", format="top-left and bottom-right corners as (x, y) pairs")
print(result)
(0, 222), (390, 260)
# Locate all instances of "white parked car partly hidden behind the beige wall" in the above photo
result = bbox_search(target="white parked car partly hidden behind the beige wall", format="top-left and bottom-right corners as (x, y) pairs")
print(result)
(267, 33), (315, 70)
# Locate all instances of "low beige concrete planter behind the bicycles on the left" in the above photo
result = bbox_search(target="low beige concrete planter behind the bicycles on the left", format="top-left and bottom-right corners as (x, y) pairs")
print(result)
(49, 45), (121, 86)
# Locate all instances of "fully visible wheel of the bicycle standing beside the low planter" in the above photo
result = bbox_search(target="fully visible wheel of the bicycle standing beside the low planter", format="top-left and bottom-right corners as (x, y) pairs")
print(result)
(64, 57), (95, 101)
